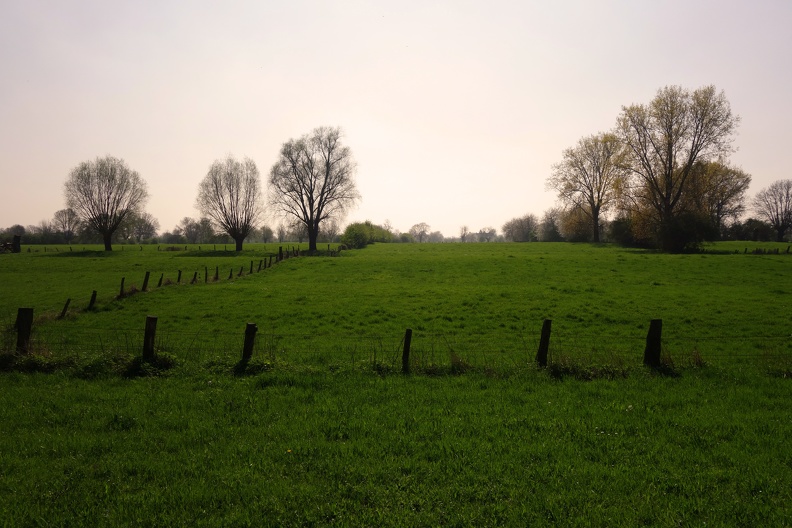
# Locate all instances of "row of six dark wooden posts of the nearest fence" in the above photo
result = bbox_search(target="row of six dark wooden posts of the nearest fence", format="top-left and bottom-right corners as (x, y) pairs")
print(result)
(16, 308), (663, 374)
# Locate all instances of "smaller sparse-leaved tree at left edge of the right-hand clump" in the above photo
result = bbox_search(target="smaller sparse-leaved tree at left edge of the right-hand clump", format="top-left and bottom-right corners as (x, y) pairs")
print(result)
(547, 133), (626, 242)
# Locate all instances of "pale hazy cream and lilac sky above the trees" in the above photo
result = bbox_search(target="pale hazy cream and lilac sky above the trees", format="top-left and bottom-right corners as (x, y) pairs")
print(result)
(0, 0), (792, 236)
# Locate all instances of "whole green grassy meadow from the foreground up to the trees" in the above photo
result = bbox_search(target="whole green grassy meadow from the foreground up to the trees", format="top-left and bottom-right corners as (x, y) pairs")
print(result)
(0, 243), (792, 526)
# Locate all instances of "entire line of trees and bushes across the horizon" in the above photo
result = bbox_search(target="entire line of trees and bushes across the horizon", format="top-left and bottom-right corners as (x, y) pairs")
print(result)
(6, 86), (792, 252)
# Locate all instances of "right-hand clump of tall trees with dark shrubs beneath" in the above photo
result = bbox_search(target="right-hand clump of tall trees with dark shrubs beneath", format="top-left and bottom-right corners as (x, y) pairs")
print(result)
(547, 86), (792, 252)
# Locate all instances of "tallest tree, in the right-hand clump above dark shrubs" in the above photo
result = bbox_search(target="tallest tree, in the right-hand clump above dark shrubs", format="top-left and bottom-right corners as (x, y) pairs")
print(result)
(617, 86), (739, 251)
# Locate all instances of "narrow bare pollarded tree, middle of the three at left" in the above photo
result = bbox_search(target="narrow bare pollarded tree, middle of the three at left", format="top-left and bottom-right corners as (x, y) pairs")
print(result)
(196, 156), (264, 251)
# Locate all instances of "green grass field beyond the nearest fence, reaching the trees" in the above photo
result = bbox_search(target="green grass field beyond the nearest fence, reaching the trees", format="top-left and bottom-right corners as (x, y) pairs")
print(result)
(0, 243), (792, 366)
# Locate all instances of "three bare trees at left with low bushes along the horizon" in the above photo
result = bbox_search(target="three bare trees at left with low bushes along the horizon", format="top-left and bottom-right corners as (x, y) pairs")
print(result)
(3, 127), (360, 251)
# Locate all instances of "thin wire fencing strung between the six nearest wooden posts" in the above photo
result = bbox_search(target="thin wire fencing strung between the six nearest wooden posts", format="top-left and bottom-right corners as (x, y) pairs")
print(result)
(1, 320), (792, 370)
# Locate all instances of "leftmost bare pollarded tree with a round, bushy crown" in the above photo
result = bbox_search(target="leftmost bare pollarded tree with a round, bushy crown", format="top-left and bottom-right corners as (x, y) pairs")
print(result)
(64, 156), (148, 251)
